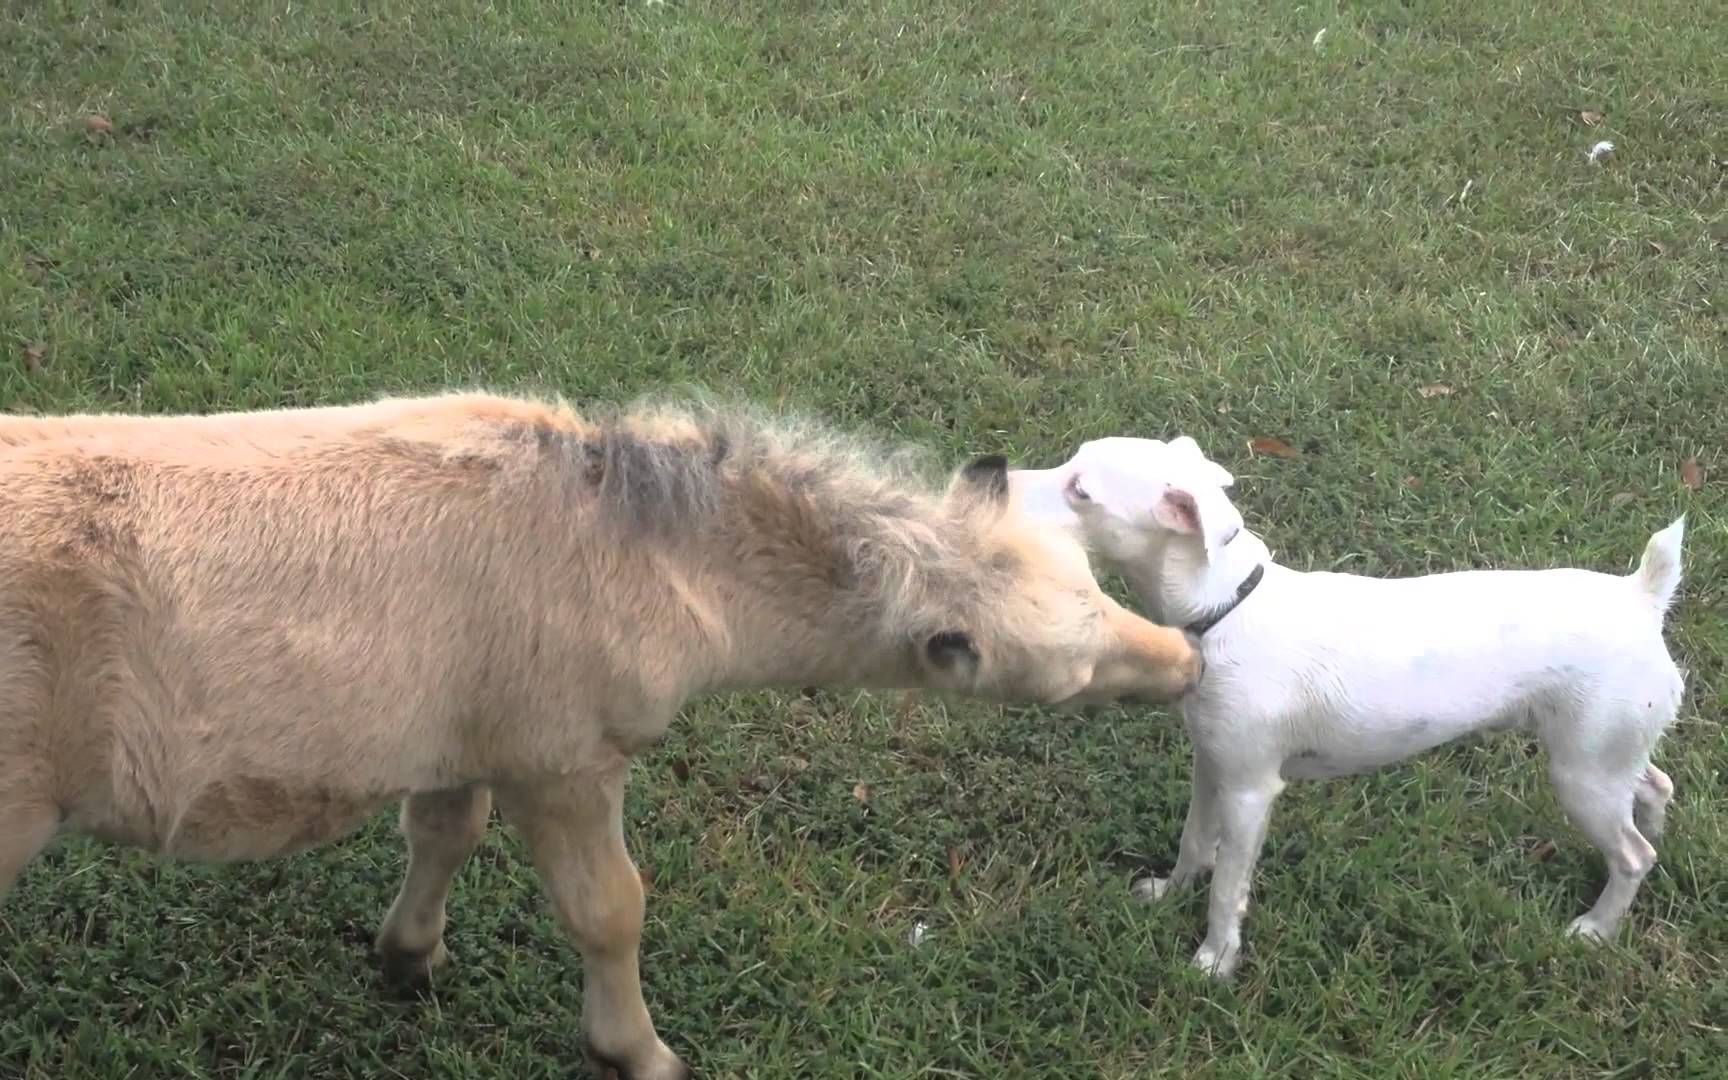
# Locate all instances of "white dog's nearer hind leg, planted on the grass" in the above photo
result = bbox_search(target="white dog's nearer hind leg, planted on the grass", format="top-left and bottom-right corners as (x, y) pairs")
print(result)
(1548, 759), (1655, 940)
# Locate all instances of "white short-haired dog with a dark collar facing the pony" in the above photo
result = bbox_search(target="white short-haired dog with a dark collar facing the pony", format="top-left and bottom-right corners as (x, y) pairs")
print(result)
(1009, 437), (1685, 978)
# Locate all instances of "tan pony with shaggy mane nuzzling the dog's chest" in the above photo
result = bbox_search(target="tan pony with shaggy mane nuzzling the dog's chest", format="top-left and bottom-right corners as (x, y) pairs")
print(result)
(0, 396), (1199, 1080)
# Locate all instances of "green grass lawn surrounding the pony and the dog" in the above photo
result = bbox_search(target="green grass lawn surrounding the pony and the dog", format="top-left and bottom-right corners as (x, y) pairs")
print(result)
(0, 0), (1728, 1078)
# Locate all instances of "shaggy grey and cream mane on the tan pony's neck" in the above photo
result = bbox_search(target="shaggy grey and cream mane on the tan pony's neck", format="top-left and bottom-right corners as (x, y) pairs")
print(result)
(501, 396), (1009, 632)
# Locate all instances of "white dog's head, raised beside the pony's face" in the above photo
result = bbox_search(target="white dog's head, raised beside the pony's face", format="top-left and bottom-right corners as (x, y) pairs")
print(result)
(1009, 435), (1242, 567)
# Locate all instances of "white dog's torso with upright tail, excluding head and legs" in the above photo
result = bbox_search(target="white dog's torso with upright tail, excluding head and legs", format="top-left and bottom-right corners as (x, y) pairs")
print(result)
(1191, 524), (1681, 776)
